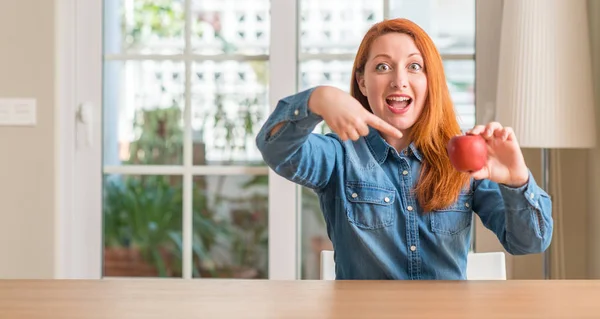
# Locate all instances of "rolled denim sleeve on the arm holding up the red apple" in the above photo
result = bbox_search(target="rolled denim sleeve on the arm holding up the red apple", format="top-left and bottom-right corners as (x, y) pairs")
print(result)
(473, 171), (553, 255)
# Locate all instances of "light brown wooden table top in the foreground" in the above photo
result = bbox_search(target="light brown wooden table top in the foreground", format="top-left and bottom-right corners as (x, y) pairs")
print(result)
(0, 279), (600, 319)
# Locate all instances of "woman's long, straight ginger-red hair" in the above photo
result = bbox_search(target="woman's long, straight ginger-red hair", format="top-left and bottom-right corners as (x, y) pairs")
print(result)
(350, 19), (470, 212)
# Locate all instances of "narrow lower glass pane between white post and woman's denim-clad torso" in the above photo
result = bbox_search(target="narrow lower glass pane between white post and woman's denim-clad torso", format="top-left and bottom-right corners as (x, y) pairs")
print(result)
(301, 187), (333, 279)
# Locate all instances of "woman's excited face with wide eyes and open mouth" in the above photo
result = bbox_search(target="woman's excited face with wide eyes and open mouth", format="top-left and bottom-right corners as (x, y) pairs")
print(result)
(357, 33), (427, 140)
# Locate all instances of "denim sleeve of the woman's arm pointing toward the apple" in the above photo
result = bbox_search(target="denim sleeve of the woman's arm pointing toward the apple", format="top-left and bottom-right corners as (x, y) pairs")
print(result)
(256, 88), (342, 190)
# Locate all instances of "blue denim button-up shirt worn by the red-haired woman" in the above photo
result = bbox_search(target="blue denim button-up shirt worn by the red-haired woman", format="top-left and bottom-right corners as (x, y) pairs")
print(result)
(256, 89), (553, 280)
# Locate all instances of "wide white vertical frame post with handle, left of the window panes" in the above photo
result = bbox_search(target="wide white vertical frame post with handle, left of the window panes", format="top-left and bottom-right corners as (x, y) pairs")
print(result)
(54, 0), (102, 279)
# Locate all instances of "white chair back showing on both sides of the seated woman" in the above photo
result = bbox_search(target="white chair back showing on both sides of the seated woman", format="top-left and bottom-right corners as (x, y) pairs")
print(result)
(321, 250), (506, 280)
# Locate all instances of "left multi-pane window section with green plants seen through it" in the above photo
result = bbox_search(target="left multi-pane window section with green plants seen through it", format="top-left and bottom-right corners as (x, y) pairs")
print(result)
(103, 0), (270, 278)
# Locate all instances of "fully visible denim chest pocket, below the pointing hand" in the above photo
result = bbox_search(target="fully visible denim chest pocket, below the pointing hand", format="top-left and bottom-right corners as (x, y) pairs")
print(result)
(345, 183), (396, 229)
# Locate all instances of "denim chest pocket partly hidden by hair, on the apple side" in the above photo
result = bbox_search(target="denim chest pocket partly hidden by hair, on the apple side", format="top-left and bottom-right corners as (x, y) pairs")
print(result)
(430, 194), (473, 235)
